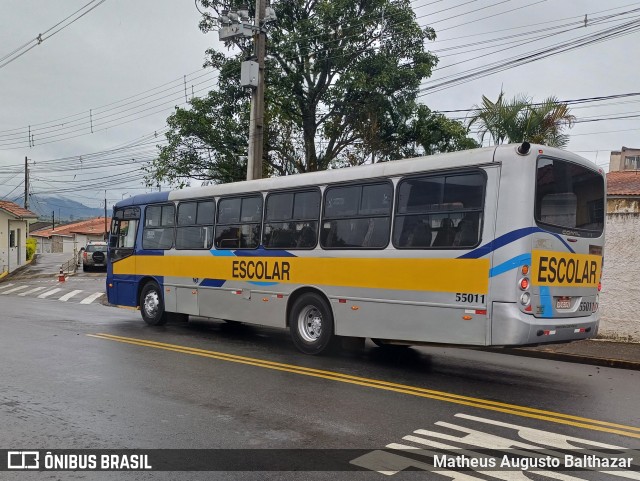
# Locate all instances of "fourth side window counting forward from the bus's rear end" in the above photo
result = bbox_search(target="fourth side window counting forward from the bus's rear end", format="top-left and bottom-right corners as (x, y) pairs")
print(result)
(215, 195), (262, 249)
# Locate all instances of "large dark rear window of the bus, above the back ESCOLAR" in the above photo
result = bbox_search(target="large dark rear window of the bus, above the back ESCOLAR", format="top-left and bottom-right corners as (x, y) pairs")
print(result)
(535, 157), (604, 236)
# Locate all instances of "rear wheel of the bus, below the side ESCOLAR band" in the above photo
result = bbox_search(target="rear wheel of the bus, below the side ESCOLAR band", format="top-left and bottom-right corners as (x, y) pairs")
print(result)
(289, 292), (333, 355)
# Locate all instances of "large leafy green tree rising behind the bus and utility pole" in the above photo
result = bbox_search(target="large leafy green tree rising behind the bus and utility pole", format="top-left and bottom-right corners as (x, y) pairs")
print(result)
(147, 0), (477, 185)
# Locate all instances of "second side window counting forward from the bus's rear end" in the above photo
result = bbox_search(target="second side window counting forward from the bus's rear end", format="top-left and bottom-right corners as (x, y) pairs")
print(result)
(320, 182), (393, 249)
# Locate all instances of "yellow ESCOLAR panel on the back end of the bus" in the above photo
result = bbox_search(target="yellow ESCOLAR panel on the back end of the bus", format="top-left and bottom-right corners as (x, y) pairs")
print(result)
(531, 250), (602, 287)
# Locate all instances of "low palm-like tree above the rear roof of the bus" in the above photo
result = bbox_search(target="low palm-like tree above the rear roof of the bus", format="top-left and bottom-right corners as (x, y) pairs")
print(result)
(467, 91), (575, 147)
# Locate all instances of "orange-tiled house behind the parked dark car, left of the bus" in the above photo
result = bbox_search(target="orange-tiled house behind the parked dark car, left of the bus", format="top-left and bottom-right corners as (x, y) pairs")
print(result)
(30, 217), (111, 255)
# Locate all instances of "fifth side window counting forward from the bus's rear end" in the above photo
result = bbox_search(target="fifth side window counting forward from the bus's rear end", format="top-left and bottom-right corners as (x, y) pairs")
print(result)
(176, 200), (215, 249)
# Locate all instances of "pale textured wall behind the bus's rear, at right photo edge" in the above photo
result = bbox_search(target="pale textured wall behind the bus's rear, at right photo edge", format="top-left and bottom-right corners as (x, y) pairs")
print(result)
(600, 213), (640, 342)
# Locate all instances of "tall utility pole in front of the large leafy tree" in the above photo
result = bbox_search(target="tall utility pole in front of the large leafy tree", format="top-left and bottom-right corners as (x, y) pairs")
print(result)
(247, 0), (267, 180)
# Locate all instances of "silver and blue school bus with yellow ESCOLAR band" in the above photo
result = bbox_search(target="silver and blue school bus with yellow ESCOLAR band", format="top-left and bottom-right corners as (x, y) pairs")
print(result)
(107, 142), (605, 354)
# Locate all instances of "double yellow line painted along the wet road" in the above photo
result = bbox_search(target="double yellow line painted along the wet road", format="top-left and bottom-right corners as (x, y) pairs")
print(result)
(88, 333), (640, 439)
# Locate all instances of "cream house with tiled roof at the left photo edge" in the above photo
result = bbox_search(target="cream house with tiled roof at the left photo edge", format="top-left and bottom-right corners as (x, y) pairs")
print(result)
(0, 200), (38, 274)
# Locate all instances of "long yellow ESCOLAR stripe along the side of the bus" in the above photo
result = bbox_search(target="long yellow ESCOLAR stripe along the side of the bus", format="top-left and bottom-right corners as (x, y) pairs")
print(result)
(113, 256), (489, 294)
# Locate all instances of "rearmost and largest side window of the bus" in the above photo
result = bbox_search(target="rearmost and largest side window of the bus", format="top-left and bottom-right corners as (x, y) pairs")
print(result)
(393, 172), (485, 249)
